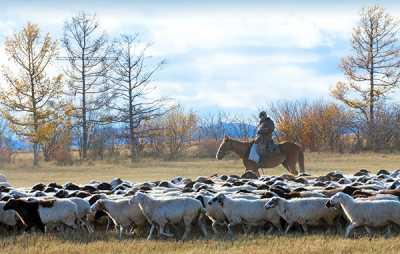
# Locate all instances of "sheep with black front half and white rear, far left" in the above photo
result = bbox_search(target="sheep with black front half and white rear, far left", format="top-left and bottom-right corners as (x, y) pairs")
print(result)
(3, 199), (78, 233)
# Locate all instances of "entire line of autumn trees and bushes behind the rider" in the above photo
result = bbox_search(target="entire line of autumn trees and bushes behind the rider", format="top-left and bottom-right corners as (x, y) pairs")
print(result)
(0, 6), (400, 165)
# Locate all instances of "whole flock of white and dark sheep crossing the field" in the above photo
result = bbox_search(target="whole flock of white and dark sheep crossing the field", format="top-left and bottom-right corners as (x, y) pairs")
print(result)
(0, 170), (400, 240)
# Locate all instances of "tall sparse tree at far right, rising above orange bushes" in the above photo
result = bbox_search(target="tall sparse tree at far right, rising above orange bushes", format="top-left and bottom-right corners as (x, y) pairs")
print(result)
(332, 6), (400, 147)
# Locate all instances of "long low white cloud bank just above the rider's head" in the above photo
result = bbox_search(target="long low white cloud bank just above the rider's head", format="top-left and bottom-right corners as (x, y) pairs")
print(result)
(153, 62), (342, 110)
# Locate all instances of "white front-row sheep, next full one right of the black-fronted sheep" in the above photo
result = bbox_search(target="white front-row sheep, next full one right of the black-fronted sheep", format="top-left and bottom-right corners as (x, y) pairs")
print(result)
(91, 196), (146, 238)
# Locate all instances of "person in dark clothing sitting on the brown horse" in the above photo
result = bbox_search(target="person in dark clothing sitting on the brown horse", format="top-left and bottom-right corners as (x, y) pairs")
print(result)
(254, 111), (275, 163)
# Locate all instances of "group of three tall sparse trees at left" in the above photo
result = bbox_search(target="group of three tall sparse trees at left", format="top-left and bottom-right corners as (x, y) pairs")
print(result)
(0, 12), (165, 165)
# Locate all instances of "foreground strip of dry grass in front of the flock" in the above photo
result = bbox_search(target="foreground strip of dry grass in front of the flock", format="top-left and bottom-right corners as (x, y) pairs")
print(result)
(0, 233), (400, 254)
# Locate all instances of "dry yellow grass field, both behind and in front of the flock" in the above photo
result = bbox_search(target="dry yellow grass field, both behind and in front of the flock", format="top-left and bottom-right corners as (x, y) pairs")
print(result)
(0, 153), (400, 254)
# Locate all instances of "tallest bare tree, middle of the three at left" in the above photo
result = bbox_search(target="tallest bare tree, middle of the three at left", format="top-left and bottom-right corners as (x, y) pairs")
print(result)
(63, 13), (115, 159)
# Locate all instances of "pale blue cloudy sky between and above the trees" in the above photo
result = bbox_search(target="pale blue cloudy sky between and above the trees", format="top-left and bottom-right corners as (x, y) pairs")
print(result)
(0, 0), (400, 114)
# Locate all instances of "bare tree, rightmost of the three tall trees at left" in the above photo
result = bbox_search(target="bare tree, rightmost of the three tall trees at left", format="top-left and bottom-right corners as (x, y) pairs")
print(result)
(110, 35), (165, 161)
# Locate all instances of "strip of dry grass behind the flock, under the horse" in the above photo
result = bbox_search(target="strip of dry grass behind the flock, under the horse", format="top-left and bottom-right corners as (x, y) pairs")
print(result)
(0, 153), (400, 186)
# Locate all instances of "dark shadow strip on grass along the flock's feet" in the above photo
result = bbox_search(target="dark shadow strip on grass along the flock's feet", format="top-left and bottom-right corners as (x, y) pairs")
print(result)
(0, 223), (400, 249)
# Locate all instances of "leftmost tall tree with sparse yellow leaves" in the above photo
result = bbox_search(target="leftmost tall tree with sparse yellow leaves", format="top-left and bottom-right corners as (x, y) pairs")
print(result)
(0, 23), (62, 166)
